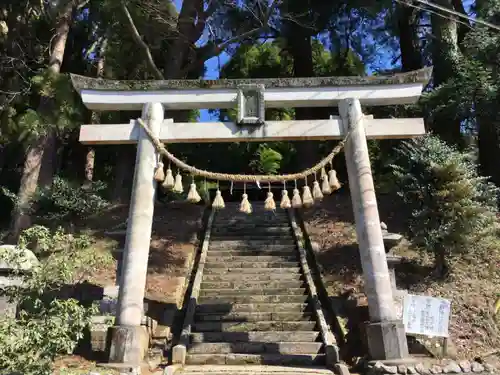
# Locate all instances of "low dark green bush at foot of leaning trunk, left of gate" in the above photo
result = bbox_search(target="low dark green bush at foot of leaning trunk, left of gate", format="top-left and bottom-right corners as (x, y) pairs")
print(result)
(36, 177), (109, 220)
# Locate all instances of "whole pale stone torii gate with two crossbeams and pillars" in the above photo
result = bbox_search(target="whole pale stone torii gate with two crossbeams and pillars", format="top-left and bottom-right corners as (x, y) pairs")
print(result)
(71, 69), (431, 363)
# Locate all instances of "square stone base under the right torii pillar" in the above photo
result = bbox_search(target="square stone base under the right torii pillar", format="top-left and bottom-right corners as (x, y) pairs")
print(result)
(366, 320), (409, 360)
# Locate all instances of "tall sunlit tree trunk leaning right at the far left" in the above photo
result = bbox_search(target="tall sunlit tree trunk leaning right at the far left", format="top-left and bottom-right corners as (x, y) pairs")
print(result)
(10, 0), (77, 242)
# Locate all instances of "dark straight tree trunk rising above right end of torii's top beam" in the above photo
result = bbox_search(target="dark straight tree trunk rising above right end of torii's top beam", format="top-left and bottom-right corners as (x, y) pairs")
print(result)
(396, 3), (422, 72)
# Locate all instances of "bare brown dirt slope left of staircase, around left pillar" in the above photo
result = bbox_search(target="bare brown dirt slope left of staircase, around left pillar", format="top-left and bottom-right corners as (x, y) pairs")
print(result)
(56, 202), (205, 375)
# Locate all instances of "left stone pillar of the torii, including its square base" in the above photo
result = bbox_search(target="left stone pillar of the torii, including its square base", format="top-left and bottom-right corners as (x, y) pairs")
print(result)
(110, 103), (164, 364)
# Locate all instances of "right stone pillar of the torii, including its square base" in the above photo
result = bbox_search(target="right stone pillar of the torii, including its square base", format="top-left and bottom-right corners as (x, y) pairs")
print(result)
(339, 99), (408, 360)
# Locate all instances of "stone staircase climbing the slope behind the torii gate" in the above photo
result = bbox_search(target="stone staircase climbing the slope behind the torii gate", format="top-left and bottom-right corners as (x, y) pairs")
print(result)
(173, 204), (336, 367)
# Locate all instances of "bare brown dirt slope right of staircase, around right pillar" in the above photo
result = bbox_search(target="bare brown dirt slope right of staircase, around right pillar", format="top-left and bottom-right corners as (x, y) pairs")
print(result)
(304, 191), (500, 368)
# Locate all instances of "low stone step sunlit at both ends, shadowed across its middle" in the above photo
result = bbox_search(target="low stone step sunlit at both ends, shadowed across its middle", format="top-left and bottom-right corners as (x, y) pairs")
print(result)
(189, 342), (323, 355)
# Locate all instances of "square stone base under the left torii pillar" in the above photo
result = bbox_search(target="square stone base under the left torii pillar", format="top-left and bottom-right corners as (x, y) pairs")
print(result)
(108, 326), (149, 365)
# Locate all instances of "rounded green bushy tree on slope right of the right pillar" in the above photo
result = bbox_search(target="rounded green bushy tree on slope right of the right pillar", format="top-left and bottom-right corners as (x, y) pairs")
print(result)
(392, 136), (498, 276)
